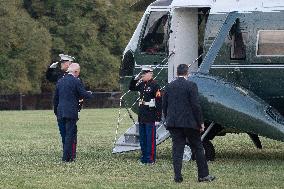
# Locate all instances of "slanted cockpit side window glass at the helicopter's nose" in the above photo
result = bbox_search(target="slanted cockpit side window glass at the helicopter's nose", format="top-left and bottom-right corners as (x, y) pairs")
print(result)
(141, 12), (169, 54)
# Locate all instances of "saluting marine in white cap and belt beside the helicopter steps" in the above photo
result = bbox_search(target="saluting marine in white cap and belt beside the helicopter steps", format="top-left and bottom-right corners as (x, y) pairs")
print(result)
(129, 66), (162, 164)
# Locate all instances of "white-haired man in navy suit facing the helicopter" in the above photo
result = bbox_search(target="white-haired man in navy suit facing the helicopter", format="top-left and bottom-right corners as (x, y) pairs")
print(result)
(54, 63), (93, 162)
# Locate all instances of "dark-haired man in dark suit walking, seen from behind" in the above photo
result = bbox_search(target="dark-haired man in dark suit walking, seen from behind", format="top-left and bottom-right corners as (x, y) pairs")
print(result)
(163, 64), (215, 182)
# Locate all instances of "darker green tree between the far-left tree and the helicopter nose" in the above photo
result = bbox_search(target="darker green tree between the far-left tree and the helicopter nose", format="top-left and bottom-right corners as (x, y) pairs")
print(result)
(25, 0), (141, 90)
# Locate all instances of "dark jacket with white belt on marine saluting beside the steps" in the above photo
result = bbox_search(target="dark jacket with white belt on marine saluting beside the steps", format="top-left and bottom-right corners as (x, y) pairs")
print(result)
(129, 78), (162, 123)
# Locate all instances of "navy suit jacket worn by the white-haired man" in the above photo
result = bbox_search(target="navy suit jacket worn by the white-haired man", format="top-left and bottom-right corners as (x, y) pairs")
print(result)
(53, 74), (93, 119)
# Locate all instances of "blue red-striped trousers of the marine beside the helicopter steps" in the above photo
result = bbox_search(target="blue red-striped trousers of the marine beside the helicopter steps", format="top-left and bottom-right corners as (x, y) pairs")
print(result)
(139, 122), (156, 163)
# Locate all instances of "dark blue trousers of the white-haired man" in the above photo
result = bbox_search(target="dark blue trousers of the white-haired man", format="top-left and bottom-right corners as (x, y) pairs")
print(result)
(62, 118), (77, 162)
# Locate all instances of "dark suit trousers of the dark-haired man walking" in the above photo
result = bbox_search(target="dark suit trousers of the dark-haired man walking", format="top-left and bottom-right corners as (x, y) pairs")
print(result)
(168, 128), (209, 178)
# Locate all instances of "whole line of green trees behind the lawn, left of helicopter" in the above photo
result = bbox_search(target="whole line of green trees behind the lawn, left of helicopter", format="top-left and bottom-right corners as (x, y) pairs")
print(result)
(0, 0), (141, 94)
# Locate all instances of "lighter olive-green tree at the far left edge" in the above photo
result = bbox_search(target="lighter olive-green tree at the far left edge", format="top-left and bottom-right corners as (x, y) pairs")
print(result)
(0, 0), (51, 94)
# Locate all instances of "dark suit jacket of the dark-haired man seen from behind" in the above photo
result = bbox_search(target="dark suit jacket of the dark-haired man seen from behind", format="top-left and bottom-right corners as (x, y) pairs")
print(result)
(163, 77), (203, 129)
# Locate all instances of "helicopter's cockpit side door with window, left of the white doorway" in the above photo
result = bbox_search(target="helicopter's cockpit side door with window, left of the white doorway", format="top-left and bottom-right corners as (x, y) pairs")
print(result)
(134, 11), (169, 66)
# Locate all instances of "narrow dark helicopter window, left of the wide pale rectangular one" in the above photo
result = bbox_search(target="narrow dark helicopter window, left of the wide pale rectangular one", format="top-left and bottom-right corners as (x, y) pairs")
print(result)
(230, 19), (247, 60)
